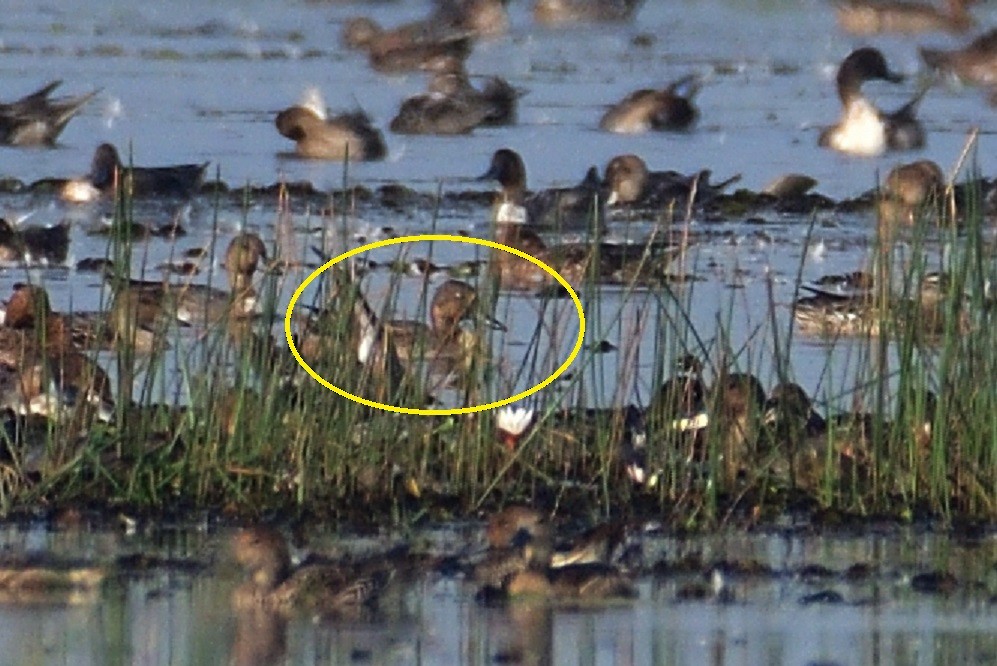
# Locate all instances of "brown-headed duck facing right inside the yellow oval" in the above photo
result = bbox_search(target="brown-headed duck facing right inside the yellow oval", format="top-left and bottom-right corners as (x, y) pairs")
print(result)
(385, 280), (505, 373)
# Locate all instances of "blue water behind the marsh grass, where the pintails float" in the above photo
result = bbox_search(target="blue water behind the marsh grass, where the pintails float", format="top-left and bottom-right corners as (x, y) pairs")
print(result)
(0, 1), (997, 404)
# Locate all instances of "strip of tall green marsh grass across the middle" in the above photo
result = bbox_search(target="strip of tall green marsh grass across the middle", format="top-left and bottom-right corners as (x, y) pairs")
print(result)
(0, 163), (997, 529)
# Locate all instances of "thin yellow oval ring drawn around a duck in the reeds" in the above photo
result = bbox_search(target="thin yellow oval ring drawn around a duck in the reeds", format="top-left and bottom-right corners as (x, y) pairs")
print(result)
(284, 234), (585, 416)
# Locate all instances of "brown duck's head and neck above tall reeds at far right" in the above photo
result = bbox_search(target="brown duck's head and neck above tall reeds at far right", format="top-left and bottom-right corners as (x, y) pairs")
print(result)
(876, 160), (945, 228)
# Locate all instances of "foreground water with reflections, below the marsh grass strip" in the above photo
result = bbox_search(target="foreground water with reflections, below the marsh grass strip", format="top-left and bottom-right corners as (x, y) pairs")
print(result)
(0, 526), (997, 666)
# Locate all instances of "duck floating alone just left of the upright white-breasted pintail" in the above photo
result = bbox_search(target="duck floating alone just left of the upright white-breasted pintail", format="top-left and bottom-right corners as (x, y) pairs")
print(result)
(599, 76), (699, 134)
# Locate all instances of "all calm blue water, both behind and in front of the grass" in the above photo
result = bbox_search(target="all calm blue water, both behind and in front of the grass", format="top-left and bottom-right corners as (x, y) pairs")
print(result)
(0, 0), (997, 665)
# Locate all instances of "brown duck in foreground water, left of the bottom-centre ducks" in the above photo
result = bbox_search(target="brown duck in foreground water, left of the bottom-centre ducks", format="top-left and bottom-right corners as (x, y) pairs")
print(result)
(232, 526), (390, 616)
